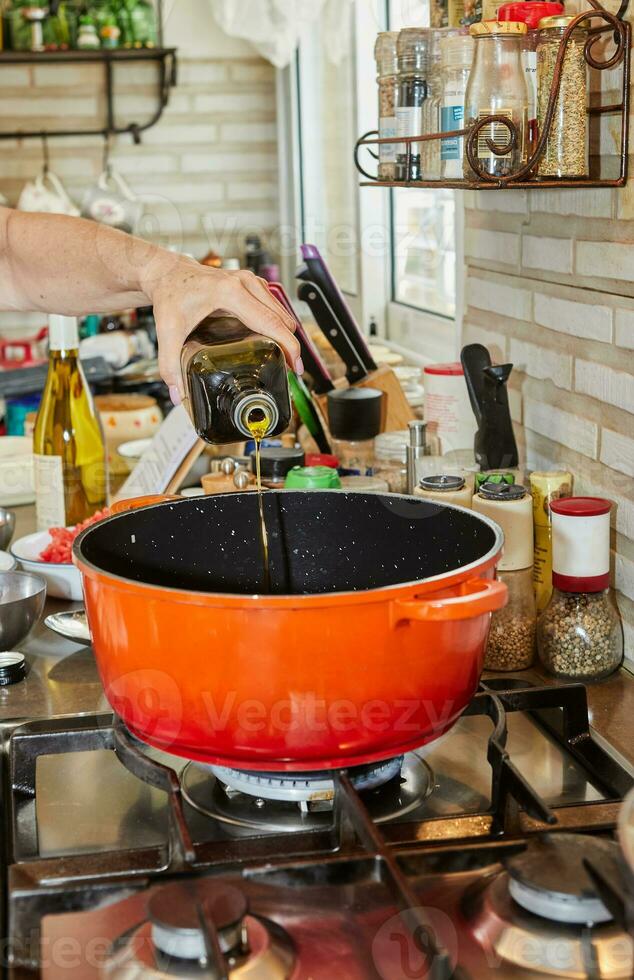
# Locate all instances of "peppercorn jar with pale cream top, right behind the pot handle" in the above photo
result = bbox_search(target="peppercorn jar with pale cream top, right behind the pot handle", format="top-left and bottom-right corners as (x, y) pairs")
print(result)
(472, 483), (536, 671)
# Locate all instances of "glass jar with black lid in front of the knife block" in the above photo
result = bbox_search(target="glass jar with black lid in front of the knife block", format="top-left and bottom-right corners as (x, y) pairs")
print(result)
(327, 388), (383, 476)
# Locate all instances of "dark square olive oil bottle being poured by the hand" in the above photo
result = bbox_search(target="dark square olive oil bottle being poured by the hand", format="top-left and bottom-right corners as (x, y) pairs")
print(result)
(181, 315), (291, 444)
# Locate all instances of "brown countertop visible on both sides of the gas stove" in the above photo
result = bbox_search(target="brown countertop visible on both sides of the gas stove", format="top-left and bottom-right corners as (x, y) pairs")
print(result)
(0, 507), (634, 764)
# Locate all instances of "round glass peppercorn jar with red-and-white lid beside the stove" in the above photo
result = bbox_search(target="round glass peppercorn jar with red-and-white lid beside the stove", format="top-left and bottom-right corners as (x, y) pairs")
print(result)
(537, 497), (623, 681)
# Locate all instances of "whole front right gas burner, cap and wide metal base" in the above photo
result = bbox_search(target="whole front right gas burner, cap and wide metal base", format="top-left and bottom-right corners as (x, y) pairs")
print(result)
(463, 833), (634, 980)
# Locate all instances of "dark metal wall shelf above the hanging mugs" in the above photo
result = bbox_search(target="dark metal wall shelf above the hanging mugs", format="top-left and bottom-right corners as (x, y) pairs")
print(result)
(0, 48), (177, 143)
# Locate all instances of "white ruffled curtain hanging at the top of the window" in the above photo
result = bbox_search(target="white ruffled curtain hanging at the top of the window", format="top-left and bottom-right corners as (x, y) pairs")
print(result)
(210, 0), (354, 68)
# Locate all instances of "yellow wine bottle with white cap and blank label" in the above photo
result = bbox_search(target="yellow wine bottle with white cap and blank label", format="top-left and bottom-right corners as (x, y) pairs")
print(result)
(33, 316), (107, 530)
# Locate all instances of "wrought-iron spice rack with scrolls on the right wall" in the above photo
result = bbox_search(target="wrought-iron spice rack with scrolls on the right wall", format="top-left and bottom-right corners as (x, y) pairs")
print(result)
(354, 0), (631, 190)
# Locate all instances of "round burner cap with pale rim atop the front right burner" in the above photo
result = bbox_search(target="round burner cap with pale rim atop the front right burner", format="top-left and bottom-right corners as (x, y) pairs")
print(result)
(506, 834), (619, 925)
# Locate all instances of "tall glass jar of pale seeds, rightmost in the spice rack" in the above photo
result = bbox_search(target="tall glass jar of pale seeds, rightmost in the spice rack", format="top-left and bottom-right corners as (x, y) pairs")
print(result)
(537, 17), (589, 178)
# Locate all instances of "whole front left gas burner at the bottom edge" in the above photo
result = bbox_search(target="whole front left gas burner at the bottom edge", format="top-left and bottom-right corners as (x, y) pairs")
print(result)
(102, 878), (294, 980)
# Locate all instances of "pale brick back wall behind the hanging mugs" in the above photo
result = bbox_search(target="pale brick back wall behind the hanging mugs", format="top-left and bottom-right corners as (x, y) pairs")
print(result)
(0, 36), (279, 335)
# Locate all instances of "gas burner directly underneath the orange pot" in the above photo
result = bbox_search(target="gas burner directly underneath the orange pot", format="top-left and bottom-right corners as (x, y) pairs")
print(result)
(181, 753), (433, 833)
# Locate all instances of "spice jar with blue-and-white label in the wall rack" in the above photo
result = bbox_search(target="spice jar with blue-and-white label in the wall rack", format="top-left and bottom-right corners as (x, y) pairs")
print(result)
(440, 30), (474, 180)
